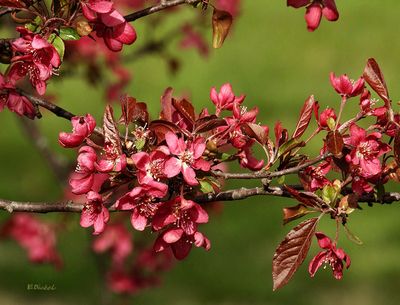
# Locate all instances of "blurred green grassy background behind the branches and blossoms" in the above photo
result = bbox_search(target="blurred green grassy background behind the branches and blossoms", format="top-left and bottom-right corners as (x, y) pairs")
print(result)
(0, 0), (400, 305)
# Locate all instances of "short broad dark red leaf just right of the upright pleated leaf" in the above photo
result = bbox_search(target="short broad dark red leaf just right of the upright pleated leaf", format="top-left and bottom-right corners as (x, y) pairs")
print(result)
(119, 95), (149, 125)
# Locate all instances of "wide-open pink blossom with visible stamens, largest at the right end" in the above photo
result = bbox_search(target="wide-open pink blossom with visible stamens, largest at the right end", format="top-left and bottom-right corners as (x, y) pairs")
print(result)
(344, 124), (391, 178)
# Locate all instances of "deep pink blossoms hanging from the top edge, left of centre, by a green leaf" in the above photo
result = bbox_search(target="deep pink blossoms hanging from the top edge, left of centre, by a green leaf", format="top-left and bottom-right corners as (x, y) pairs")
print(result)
(81, 0), (136, 51)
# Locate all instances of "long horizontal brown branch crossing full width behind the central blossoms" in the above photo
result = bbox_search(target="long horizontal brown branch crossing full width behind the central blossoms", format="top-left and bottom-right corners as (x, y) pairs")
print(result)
(0, 186), (400, 213)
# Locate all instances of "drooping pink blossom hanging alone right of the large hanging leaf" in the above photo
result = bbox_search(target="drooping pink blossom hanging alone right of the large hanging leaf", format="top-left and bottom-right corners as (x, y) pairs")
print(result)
(308, 232), (350, 280)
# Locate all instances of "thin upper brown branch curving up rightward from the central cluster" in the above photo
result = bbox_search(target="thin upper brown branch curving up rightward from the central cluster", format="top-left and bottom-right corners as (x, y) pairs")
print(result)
(212, 153), (332, 179)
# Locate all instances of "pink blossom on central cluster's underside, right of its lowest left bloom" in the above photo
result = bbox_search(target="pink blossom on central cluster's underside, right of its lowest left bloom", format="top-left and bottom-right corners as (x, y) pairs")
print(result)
(115, 183), (168, 231)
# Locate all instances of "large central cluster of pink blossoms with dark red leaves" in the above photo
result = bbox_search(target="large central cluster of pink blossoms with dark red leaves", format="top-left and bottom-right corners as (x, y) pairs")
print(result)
(59, 84), (268, 259)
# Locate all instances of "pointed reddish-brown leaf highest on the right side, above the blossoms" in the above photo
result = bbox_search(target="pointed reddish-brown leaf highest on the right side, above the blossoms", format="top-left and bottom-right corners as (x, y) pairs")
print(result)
(363, 58), (390, 104)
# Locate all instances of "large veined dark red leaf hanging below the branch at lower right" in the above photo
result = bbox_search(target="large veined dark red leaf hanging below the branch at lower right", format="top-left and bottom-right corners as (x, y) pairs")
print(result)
(272, 218), (319, 290)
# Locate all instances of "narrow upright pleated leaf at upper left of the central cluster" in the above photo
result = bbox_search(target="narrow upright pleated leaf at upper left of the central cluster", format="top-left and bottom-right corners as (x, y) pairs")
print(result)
(103, 105), (122, 156)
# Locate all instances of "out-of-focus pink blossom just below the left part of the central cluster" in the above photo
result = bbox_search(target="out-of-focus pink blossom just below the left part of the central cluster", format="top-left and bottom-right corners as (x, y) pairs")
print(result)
(92, 224), (133, 265)
